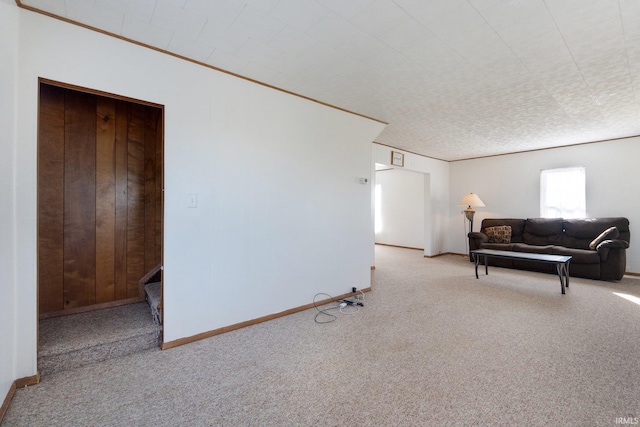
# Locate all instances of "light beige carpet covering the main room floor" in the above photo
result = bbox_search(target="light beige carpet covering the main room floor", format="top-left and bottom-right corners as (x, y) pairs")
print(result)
(2, 246), (640, 426)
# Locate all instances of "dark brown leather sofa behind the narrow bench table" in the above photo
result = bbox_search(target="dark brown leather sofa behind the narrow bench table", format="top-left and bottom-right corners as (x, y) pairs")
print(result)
(468, 217), (631, 280)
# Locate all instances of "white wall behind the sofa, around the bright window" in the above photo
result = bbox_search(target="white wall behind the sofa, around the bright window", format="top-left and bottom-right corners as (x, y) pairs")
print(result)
(449, 137), (640, 273)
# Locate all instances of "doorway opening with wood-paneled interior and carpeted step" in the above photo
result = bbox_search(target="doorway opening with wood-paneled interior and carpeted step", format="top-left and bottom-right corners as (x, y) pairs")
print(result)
(37, 79), (164, 374)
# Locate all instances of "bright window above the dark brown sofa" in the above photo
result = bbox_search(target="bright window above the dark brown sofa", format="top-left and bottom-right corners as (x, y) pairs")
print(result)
(540, 167), (586, 218)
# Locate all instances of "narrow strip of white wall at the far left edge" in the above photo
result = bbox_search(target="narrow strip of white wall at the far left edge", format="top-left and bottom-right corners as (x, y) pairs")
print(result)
(0, 0), (18, 402)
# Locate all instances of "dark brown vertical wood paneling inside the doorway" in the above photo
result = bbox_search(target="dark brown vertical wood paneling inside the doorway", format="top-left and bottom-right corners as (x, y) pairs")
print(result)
(38, 83), (163, 316)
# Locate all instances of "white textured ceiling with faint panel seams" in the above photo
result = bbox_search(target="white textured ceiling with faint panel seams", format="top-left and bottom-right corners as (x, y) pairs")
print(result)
(19, 0), (640, 160)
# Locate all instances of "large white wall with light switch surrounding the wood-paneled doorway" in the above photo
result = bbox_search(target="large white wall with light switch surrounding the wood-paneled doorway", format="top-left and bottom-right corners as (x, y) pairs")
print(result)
(16, 3), (384, 377)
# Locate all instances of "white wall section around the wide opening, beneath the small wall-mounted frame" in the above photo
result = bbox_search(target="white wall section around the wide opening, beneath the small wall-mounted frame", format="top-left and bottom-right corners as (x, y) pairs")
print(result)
(373, 144), (451, 256)
